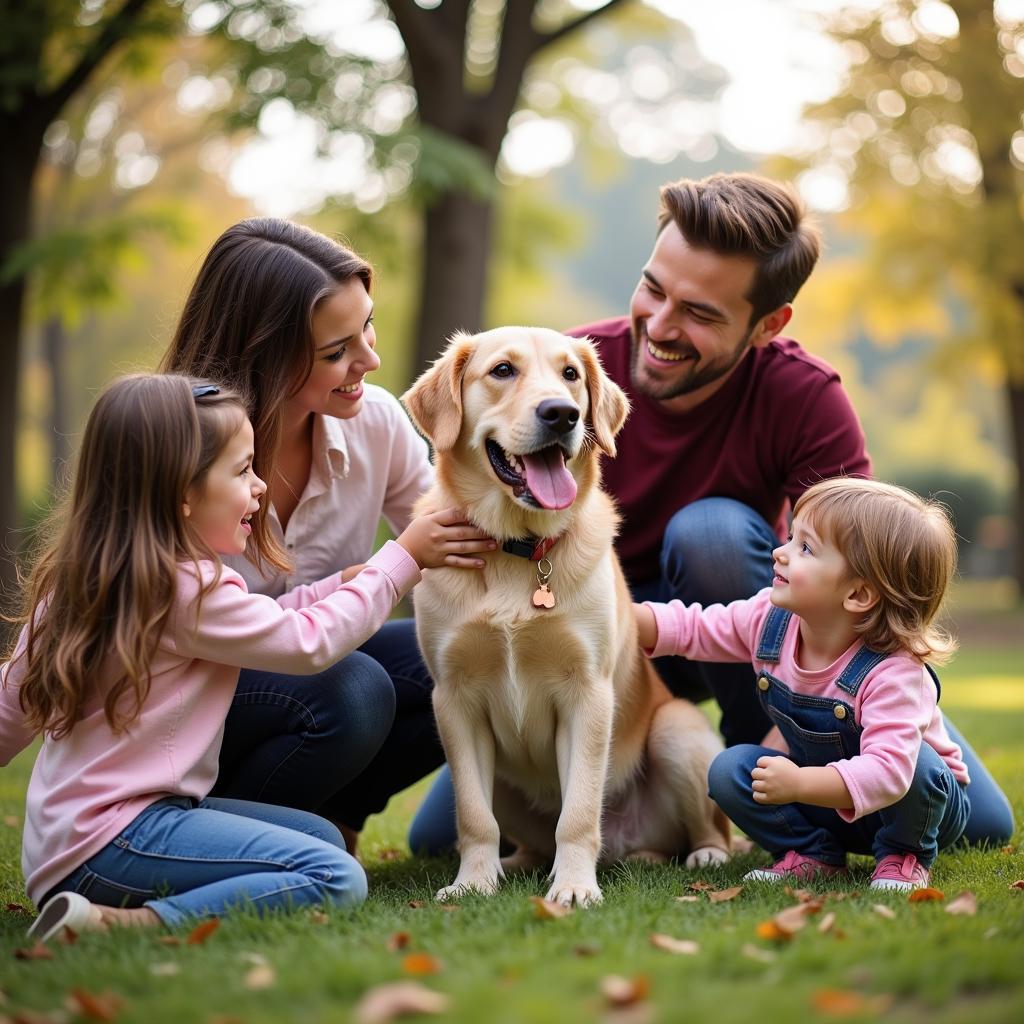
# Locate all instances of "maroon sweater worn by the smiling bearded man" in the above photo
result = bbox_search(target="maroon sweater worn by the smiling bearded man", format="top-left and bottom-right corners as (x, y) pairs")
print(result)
(568, 316), (871, 583)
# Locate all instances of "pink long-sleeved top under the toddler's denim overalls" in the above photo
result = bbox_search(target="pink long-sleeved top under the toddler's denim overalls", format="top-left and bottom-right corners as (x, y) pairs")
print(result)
(648, 589), (969, 821)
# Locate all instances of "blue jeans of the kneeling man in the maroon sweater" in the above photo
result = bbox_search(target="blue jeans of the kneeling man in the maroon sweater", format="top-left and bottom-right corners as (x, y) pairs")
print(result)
(409, 498), (1014, 853)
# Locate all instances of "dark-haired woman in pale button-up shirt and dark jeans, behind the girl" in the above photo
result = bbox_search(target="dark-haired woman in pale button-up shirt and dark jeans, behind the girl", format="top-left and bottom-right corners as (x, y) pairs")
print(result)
(163, 219), (456, 849)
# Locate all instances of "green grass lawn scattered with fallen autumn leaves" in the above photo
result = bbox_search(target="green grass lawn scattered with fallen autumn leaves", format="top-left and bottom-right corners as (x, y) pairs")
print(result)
(0, 648), (1024, 1024)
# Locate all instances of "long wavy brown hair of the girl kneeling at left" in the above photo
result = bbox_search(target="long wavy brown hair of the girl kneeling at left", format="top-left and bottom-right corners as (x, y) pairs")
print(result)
(10, 374), (249, 739)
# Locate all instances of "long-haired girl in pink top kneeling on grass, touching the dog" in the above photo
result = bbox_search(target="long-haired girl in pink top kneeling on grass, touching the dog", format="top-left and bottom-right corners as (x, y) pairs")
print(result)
(0, 375), (491, 941)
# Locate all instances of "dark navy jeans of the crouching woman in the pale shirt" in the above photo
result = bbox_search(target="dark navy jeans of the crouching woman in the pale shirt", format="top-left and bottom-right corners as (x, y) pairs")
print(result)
(213, 620), (444, 830)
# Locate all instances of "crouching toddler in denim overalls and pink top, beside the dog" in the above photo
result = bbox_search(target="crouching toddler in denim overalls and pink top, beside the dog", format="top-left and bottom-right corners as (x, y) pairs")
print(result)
(635, 478), (969, 889)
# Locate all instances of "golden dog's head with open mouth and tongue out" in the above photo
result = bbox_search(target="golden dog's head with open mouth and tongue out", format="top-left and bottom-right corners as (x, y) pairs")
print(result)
(402, 327), (629, 525)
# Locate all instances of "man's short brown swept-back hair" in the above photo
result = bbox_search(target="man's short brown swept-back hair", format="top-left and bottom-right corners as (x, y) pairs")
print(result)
(657, 174), (821, 324)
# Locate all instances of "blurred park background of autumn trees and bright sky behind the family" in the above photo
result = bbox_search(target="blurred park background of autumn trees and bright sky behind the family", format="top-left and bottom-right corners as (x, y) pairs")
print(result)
(0, 0), (1024, 622)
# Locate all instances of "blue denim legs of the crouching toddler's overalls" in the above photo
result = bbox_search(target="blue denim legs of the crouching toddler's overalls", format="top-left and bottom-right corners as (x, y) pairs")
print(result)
(708, 743), (970, 867)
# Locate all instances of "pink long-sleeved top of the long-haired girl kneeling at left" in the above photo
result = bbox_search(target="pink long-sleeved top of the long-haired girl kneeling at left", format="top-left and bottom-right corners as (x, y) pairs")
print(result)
(0, 541), (420, 902)
